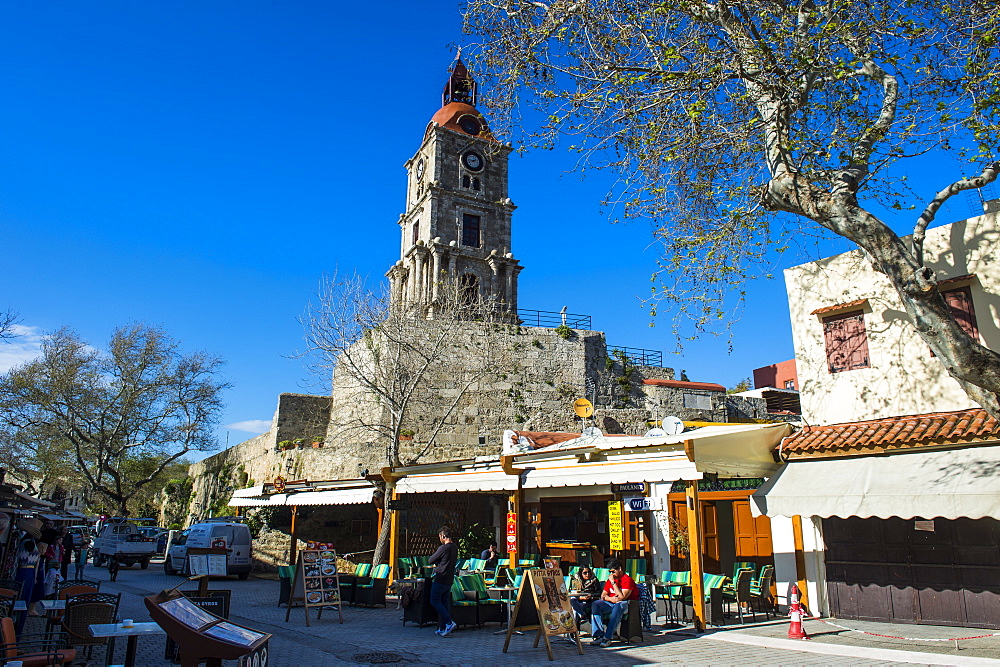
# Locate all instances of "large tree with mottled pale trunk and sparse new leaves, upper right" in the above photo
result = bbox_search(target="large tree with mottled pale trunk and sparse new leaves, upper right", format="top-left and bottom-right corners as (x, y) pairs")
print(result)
(465, 0), (1000, 416)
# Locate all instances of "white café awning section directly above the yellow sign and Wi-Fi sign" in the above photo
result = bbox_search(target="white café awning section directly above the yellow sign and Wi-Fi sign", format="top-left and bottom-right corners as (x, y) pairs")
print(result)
(524, 453), (702, 489)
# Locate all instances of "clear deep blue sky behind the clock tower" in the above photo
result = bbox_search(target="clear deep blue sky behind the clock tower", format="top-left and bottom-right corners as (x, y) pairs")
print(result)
(0, 0), (984, 460)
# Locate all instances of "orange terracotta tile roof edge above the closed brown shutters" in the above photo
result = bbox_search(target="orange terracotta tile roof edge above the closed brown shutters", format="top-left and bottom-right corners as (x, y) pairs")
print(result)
(781, 408), (1000, 459)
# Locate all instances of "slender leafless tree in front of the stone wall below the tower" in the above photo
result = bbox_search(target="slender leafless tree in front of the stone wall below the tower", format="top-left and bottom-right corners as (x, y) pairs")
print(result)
(303, 275), (523, 564)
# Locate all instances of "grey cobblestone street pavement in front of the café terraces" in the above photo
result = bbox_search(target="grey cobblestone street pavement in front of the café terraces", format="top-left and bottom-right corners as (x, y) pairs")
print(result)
(41, 563), (1000, 667)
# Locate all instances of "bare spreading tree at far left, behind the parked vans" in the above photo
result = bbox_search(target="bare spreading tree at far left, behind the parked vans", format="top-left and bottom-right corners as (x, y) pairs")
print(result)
(0, 325), (228, 515)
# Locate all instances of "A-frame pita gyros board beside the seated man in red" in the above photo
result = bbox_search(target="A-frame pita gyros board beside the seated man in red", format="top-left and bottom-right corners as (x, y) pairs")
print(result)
(503, 569), (583, 660)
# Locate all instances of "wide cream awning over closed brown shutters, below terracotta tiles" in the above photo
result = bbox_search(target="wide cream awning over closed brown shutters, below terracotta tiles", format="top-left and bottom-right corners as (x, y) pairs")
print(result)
(751, 446), (1000, 519)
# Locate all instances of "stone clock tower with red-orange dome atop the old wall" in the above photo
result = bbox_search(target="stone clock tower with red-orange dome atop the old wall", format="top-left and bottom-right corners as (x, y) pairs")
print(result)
(386, 58), (522, 322)
